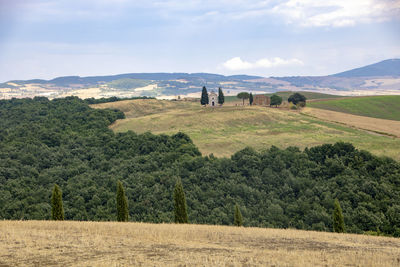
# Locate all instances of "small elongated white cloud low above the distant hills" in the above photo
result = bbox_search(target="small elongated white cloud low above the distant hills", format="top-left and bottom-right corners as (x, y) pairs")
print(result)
(222, 57), (304, 71)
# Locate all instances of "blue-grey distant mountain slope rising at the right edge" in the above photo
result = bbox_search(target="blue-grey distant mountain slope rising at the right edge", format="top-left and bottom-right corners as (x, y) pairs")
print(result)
(332, 59), (400, 78)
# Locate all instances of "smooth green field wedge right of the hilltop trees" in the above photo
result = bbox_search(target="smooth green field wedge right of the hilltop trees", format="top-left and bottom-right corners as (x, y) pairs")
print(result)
(307, 96), (400, 121)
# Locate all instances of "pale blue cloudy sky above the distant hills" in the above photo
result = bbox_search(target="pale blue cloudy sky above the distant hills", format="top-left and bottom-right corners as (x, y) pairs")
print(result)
(0, 0), (400, 82)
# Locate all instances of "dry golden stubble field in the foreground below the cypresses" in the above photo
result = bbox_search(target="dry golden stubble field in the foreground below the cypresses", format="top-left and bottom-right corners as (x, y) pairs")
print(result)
(0, 221), (400, 267)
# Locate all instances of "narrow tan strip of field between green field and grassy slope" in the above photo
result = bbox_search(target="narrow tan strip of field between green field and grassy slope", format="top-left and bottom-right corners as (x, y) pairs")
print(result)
(302, 107), (400, 138)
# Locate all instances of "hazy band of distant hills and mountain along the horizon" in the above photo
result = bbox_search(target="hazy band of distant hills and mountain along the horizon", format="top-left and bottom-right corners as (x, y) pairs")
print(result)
(0, 59), (400, 99)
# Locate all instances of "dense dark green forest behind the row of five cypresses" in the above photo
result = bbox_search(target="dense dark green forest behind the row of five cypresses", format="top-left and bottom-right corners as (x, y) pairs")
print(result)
(0, 97), (400, 236)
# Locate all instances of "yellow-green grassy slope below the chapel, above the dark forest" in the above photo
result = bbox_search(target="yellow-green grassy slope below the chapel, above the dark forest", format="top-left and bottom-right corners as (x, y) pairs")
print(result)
(95, 100), (400, 160)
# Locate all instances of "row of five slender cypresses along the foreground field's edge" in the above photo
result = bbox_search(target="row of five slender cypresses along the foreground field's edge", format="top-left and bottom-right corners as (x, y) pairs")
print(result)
(51, 183), (345, 233)
